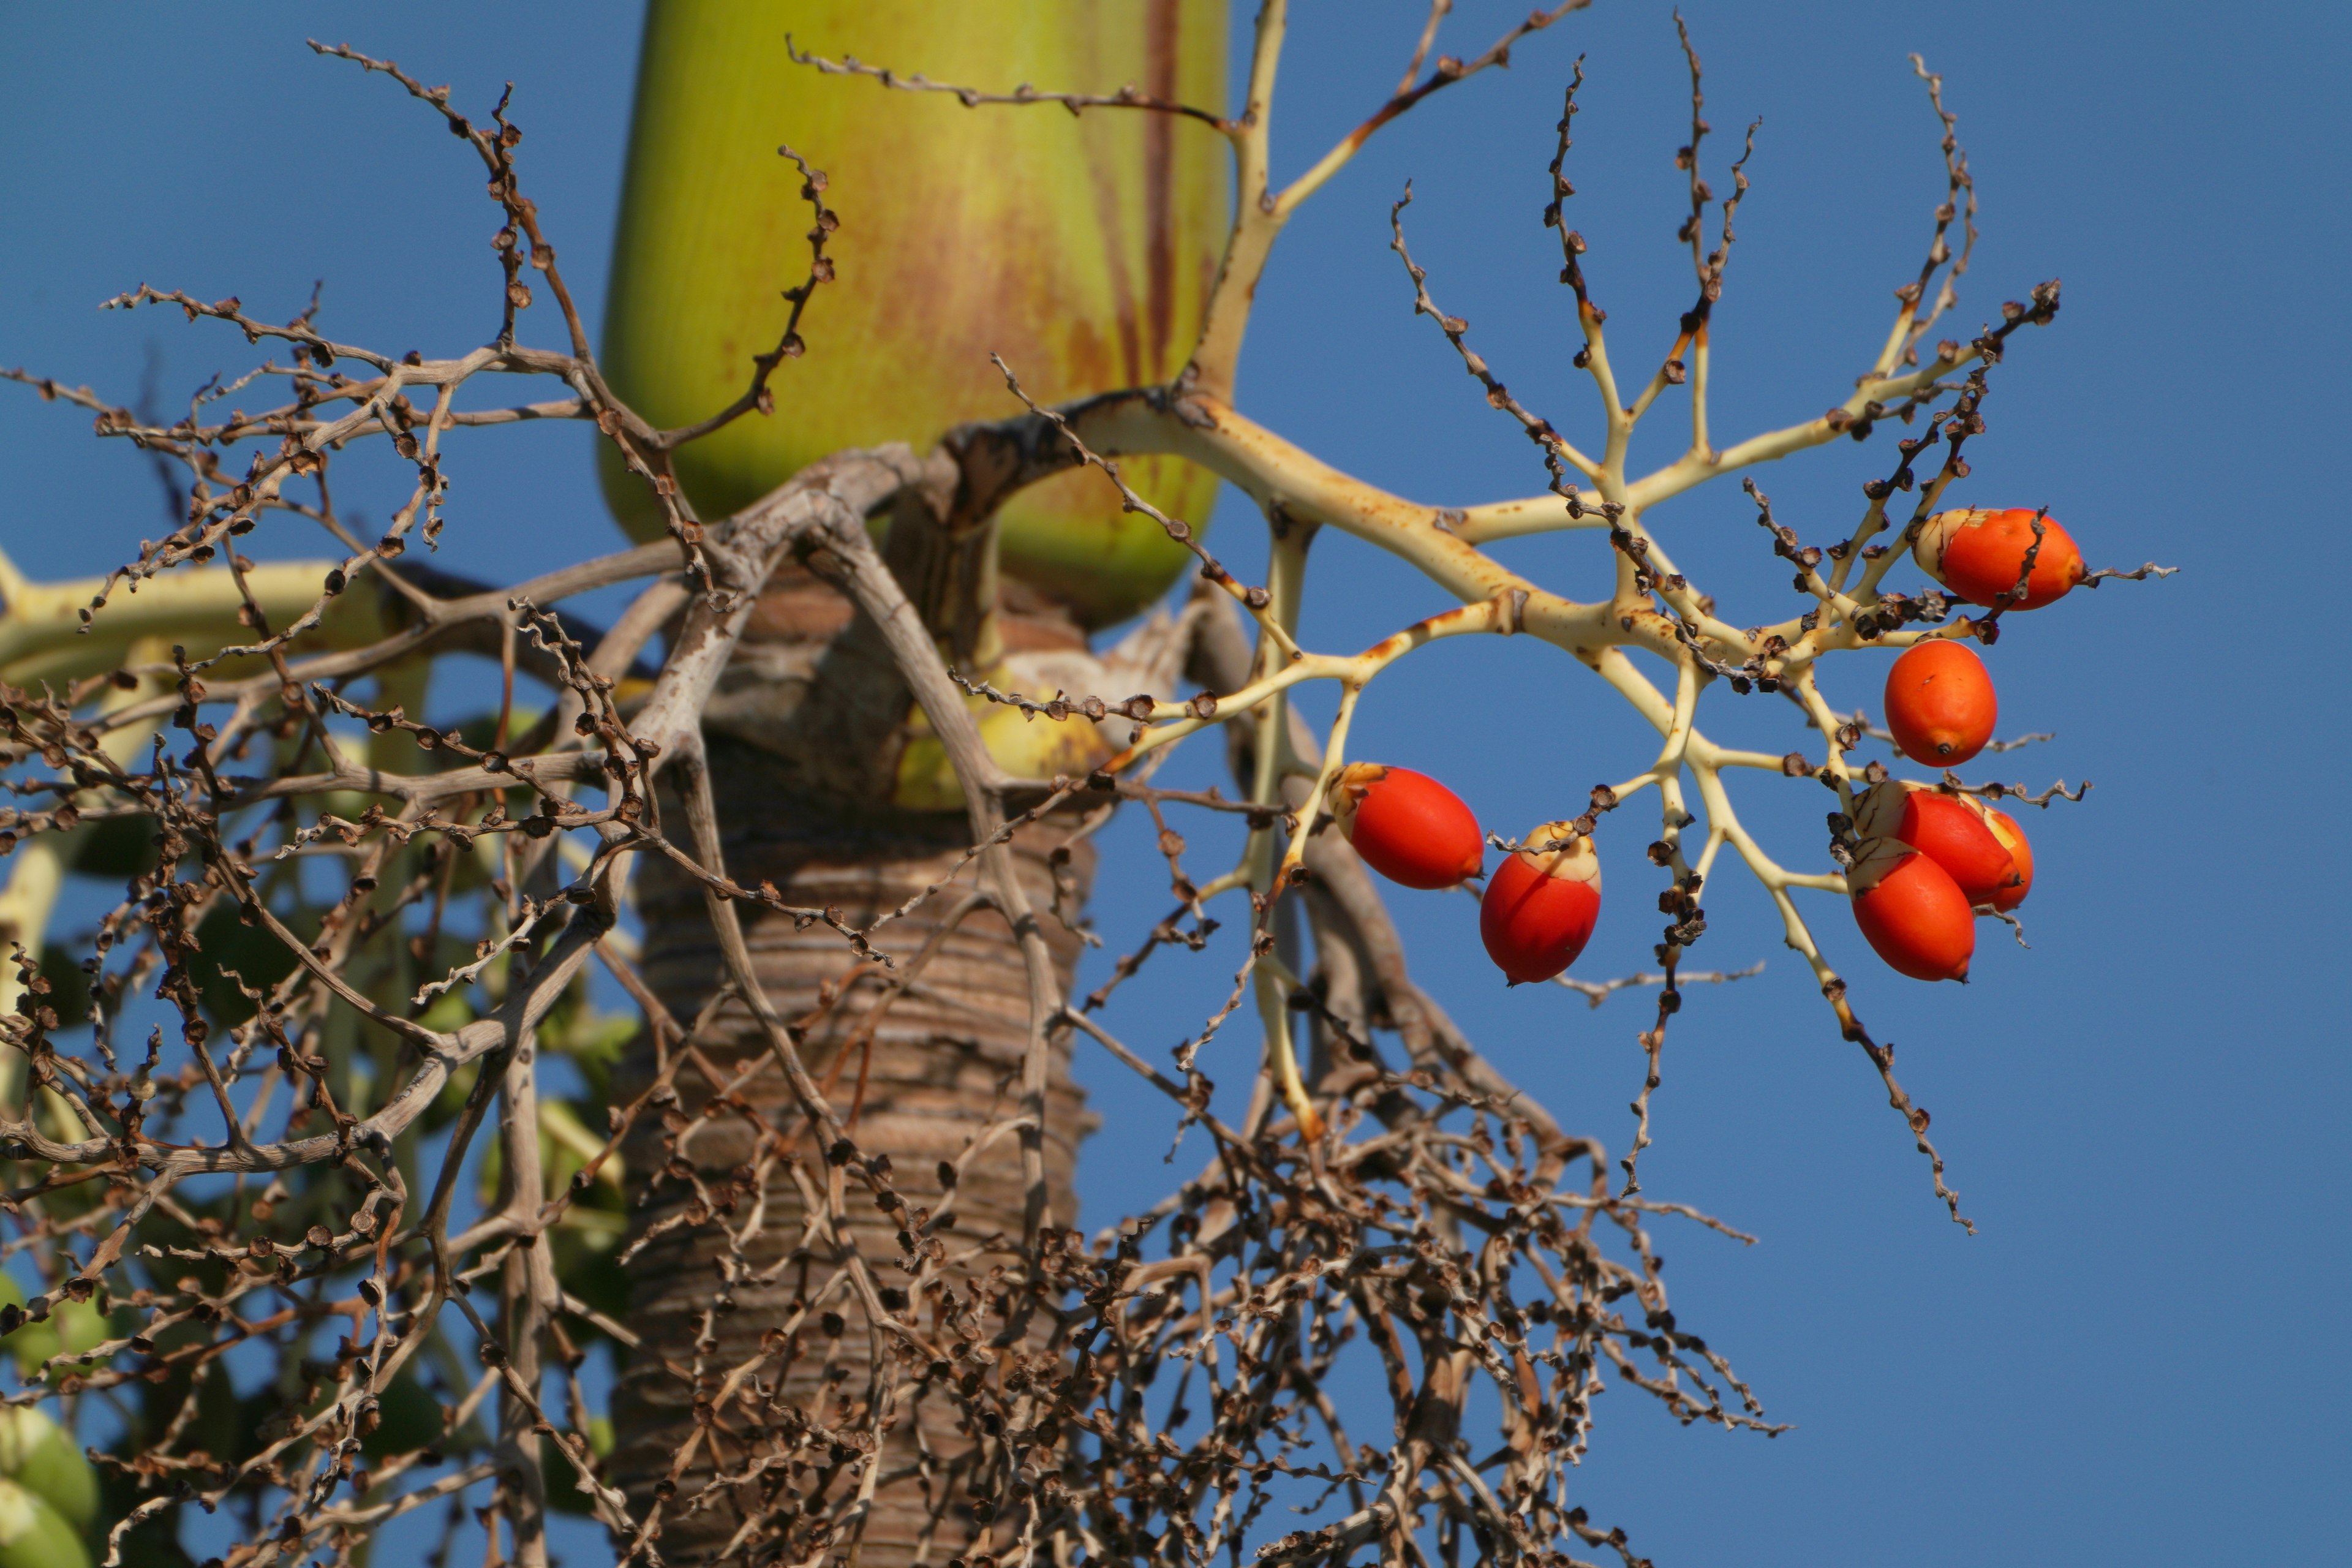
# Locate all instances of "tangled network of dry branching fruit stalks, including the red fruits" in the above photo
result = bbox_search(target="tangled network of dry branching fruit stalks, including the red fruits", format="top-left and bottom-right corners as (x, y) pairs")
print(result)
(0, 12), (2159, 1568)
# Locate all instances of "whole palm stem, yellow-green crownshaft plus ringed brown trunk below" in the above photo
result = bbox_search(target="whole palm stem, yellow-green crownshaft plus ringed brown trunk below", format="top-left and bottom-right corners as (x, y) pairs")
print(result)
(605, 0), (1227, 1568)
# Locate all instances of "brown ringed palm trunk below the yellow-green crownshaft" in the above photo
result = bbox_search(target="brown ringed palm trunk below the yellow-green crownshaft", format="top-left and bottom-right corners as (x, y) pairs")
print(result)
(597, 578), (1094, 1568)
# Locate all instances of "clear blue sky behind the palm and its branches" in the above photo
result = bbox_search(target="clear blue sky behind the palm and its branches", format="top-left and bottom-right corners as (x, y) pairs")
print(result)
(0, 0), (2352, 1568)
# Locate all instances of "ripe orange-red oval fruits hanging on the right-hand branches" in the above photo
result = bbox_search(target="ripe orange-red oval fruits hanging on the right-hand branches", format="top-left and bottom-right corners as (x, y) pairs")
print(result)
(1331, 510), (2084, 985)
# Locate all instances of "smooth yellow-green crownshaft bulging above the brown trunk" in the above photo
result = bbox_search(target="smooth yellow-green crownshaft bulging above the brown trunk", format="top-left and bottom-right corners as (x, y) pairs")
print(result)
(605, 0), (1227, 625)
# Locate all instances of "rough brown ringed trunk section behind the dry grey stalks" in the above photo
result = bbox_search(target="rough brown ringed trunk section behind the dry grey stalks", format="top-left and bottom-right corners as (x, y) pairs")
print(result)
(616, 780), (1091, 1566)
